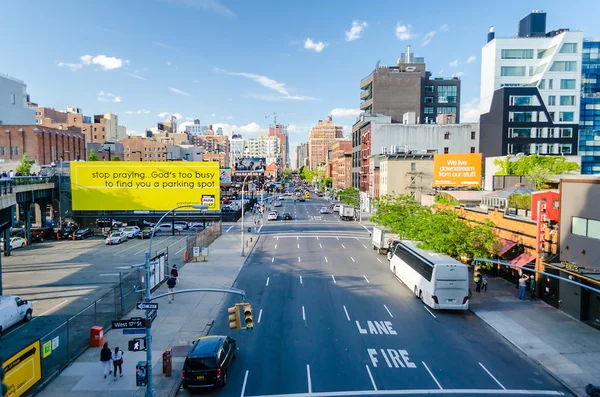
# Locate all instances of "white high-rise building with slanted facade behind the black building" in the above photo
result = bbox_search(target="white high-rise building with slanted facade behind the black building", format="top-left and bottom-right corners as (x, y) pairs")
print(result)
(480, 11), (583, 123)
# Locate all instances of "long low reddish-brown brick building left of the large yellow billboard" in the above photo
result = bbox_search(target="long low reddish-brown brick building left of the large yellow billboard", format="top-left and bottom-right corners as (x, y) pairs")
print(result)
(0, 125), (85, 165)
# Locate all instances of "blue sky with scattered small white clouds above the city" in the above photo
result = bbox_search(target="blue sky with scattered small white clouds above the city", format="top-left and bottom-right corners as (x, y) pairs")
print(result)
(0, 0), (600, 155)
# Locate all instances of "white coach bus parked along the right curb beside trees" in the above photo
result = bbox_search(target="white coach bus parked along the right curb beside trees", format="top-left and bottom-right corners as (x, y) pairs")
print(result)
(390, 240), (469, 310)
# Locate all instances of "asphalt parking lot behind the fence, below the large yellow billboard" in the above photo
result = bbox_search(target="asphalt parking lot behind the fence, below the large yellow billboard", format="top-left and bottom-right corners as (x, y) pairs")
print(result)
(2, 229), (186, 356)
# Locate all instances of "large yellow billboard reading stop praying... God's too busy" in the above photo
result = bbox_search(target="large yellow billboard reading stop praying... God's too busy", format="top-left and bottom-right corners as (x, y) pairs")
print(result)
(71, 161), (221, 211)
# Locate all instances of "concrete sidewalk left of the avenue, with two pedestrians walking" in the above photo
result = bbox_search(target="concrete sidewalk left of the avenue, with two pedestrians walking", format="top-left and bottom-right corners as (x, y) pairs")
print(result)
(38, 233), (256, 397)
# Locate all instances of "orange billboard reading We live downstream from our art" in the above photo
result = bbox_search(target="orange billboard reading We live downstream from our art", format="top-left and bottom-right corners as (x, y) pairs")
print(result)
(433, 153), (481, 186)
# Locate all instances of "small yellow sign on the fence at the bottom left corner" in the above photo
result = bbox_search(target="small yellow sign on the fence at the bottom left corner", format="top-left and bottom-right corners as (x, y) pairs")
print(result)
(3, 340), (42, 397)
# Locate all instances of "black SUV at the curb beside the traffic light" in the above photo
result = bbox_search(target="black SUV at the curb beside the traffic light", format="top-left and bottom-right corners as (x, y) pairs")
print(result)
(181, 335), (237, 389)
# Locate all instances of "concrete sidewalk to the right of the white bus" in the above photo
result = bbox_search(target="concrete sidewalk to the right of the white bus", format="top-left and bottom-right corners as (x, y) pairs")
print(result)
(470, 278), (600, 396)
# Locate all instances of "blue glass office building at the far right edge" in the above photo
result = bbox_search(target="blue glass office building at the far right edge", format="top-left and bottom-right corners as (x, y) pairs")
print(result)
(579, 39), (600, 174)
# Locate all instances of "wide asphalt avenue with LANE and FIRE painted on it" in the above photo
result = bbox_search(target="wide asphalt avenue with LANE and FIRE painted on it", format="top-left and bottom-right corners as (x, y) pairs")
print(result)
(177, 199), (571, 397)
